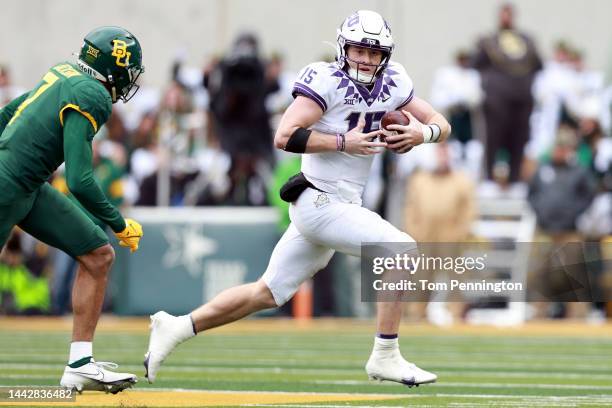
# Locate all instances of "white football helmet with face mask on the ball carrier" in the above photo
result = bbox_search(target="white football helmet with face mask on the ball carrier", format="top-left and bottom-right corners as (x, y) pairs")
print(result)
(336, 10), (395, 85)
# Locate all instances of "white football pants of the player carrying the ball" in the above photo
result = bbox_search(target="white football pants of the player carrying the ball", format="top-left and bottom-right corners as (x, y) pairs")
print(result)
(262, 188), (416, 306)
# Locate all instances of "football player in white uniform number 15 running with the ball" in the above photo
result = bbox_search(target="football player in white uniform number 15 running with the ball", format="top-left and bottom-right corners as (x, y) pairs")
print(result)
(145, 10), (450, 386)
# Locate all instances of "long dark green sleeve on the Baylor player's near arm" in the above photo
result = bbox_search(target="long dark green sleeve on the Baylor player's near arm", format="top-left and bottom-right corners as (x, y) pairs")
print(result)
(64, 110), (125, 232)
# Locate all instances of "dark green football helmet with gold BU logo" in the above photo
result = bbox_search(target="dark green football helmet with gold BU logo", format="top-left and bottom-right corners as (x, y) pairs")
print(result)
(77, 27), (144, 103)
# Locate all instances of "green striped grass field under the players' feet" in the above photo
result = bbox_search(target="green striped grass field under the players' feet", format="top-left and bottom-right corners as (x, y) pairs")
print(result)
(0, 319), (612, 407)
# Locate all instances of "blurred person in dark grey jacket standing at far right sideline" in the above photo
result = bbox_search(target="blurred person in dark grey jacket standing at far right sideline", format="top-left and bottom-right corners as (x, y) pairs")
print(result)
(528, 126), (596, 318)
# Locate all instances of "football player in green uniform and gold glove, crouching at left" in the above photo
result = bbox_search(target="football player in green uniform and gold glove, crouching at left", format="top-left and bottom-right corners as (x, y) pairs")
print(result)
(0, 27), (144, 393)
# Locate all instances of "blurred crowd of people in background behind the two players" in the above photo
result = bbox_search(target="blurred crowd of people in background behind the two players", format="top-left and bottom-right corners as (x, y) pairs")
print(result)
(0, 5), (612, 315)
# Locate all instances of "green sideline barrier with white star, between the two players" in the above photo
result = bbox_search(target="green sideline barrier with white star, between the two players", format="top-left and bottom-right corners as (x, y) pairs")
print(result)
(110, 207), (279, 315)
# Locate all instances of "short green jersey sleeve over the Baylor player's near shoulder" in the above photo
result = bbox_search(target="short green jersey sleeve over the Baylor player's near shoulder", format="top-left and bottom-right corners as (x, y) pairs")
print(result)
(59, 80), (113, 141)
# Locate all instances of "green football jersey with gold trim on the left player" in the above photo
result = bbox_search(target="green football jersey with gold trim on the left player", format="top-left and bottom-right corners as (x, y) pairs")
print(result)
(0, 62), (112, 193)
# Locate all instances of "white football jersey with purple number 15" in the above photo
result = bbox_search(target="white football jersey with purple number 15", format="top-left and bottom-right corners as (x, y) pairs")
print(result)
(292, 61), (414, 201)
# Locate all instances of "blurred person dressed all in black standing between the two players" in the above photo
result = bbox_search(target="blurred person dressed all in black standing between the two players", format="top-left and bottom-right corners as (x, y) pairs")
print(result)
(205, 33), (279, 205)
